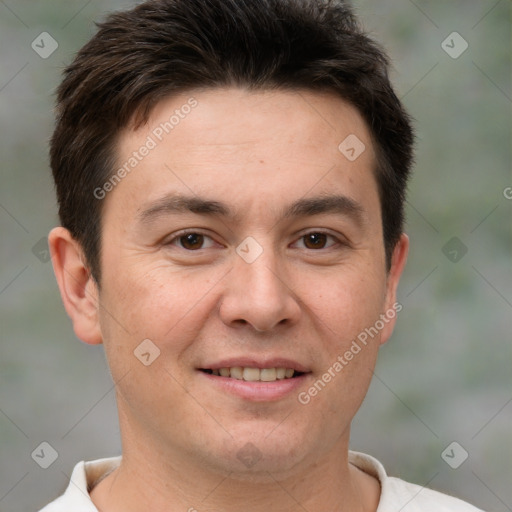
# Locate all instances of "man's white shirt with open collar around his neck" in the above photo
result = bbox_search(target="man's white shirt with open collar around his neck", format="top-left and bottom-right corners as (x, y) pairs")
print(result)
(40, 451), (483, 512)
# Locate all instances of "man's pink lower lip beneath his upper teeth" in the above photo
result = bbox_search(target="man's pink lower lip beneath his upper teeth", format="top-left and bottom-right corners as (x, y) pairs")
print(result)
(199, 371), (308, 402)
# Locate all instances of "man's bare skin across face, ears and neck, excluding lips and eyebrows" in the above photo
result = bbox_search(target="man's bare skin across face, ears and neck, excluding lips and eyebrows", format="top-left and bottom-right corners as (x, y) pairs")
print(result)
(49, 89), (408, 512)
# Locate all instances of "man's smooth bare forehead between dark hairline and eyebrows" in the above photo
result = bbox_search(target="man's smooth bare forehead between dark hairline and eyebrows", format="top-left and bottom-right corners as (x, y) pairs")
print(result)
(108, 88), (378, 222)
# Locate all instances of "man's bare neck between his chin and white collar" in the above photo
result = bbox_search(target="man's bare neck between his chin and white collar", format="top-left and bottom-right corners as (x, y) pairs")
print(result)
(91, 412), (380, 512)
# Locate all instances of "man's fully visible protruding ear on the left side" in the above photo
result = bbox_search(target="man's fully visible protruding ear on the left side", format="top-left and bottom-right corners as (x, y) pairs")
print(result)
(48, 227), (103, 345)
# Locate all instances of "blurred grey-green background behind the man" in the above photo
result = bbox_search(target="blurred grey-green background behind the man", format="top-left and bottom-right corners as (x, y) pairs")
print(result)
(0, 0), (512, 512)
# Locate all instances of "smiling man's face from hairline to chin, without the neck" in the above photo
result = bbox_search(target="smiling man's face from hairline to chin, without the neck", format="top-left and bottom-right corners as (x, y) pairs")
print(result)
(92, 89), (406, 472)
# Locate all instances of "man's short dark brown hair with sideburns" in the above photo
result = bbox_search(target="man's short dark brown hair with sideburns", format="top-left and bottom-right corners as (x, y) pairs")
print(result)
(50, 0), (414, 284)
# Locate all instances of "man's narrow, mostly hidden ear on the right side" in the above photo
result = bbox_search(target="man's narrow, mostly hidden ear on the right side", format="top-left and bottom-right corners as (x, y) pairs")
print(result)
(380, 233), (409, 344)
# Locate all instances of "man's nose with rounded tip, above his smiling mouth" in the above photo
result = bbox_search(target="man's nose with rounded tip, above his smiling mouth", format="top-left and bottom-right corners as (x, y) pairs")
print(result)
(219, 244), (300, 332)
